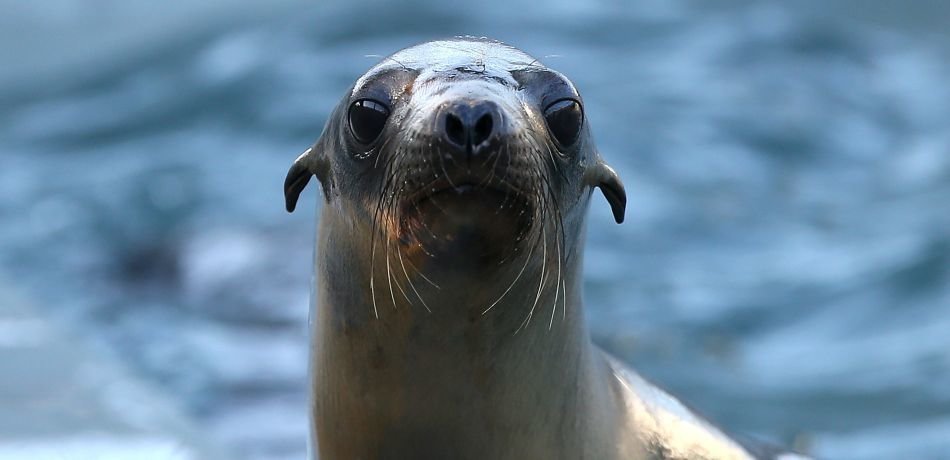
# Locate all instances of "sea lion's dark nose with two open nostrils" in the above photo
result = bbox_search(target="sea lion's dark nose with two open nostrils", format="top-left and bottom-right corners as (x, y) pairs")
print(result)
(439, 101), (501, 156)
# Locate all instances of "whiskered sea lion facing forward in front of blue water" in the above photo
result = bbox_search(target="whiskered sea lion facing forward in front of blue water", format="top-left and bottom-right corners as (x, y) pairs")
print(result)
(284, 38), (812, 460)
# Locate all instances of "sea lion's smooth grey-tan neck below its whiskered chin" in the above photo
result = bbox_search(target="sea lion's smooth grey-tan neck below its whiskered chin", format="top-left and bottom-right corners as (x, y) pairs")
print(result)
(312, 209), (613, 458)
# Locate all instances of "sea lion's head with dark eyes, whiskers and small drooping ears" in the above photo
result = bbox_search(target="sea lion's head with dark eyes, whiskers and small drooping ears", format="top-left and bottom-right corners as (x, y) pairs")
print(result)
(285, 39), (624, 274)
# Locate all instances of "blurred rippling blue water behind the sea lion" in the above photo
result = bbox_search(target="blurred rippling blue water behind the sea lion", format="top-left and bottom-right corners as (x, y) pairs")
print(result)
(0, 0), (950, 460)
